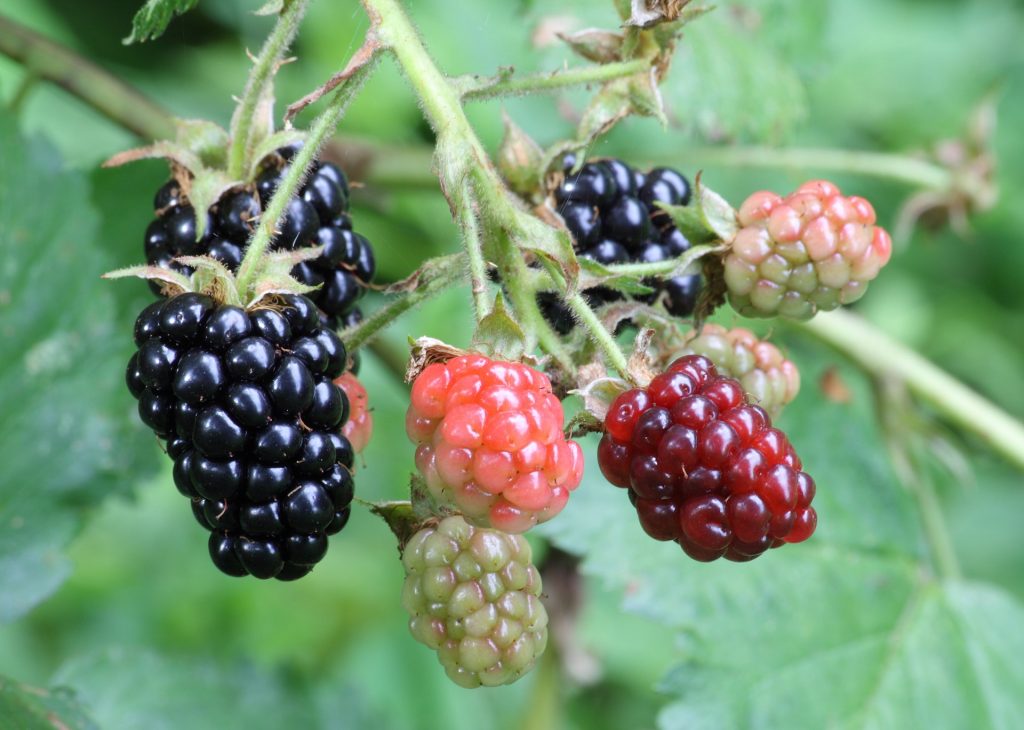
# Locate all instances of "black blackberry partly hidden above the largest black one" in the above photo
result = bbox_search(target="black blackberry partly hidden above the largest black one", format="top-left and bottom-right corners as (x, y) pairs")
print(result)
(145, 148), (376, 329)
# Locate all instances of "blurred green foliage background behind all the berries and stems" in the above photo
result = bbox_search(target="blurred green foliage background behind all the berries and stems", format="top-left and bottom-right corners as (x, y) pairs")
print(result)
(0, 0), (1024, 730)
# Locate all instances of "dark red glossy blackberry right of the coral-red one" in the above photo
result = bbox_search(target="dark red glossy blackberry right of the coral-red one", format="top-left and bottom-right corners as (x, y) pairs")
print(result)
(597, 355), (817, 561)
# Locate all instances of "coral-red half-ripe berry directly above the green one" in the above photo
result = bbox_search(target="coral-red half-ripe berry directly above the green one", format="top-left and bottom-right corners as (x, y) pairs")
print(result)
(406, 354), (584, 532)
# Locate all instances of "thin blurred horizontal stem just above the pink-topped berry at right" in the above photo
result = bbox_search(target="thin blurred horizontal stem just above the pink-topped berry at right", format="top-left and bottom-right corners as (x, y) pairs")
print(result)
(683, 146), (953, 190)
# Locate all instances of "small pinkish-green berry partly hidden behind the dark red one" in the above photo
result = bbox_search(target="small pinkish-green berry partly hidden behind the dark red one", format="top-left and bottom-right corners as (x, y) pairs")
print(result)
(669, 325), (800, 418)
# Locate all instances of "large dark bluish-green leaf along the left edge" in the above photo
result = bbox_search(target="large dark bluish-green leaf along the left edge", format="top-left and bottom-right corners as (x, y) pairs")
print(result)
(0, 120), (157, 620)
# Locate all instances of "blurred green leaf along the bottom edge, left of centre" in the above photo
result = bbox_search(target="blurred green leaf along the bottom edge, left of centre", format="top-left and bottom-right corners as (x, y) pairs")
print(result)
(55, 648), (359, 730)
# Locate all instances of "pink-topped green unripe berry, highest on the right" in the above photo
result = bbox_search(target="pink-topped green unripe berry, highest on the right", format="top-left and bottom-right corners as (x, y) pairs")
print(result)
(725, 180), (892, 319)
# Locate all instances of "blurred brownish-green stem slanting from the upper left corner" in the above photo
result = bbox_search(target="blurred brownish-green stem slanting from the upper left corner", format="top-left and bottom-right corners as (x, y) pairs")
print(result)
(0, 15), (174, 139)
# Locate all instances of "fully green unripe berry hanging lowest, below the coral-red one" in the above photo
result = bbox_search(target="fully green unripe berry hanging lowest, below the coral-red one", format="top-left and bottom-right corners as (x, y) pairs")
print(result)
(401, 516), (548, 689)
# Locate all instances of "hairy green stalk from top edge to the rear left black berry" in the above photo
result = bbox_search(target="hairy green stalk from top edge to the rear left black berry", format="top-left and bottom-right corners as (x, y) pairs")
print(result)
(227, 0), (309, 180)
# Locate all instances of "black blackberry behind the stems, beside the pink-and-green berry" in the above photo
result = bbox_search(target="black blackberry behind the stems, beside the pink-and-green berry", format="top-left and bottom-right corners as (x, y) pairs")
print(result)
(540, 156), (700, 335)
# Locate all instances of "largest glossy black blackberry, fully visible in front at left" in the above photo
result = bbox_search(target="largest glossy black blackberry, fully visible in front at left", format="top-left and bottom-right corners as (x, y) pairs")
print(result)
(126, 293), (353, 581)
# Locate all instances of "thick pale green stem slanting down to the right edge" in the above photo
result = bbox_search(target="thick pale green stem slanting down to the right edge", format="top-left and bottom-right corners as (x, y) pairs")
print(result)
(794, 310), (1024, 469)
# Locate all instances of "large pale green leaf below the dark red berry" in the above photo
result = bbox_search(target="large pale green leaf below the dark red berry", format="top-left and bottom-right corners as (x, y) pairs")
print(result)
(538, 347), (1024, 729)
